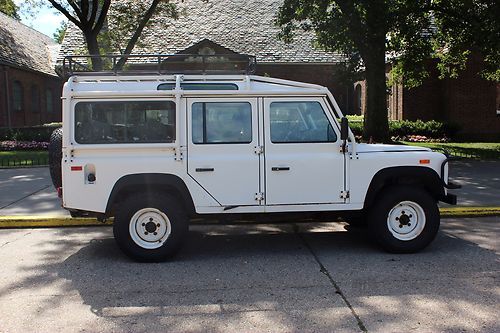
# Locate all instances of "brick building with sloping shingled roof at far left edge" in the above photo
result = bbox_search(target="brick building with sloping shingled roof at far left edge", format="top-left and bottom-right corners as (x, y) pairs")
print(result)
(0, 13), (63, 127)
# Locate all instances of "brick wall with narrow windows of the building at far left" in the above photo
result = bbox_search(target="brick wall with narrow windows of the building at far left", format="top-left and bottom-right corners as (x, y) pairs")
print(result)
(0, 66), (63, 127)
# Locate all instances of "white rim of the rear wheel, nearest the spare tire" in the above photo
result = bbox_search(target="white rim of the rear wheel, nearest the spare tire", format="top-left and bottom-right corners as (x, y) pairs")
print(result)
(129, 208), (172, 250)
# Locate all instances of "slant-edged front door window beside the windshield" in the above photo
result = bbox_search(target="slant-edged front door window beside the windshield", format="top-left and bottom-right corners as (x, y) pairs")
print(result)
(269, 101), (337, 143)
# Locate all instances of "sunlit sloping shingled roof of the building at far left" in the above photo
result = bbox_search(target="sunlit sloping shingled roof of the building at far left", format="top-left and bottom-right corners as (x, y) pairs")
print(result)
(0, 13), (59, 76)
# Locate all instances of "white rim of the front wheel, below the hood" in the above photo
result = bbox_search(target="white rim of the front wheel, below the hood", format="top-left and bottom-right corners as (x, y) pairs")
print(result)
(387, 201), (425, 241)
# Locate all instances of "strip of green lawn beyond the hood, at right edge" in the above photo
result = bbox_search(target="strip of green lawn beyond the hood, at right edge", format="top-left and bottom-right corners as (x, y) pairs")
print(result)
(401, 142), (500, 159)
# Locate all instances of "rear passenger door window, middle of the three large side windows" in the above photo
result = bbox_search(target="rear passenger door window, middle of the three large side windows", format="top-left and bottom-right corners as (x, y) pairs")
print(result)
(192, 102), (252, 144)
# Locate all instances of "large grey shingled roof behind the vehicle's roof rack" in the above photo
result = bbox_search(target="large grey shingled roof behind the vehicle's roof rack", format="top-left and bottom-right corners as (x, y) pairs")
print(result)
(61, 0), (343, 63)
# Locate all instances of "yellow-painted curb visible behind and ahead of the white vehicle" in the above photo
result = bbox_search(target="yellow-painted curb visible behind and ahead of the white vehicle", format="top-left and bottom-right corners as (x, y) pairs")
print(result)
(0, 207), (500, 229)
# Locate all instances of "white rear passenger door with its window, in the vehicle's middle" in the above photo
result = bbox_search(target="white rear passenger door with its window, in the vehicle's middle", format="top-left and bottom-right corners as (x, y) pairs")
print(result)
(187, 98), (261, 206)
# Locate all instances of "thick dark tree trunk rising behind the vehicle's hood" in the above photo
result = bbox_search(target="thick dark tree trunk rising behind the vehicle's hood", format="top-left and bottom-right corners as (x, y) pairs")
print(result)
(363, 45), (390, 142)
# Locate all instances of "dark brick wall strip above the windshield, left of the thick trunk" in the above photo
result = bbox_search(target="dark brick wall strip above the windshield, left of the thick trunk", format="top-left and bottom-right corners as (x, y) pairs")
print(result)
(256, 63), (354, 114)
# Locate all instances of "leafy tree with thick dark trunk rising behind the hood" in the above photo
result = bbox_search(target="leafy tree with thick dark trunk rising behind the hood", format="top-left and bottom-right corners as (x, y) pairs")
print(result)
(276, 0), (500, 141)
